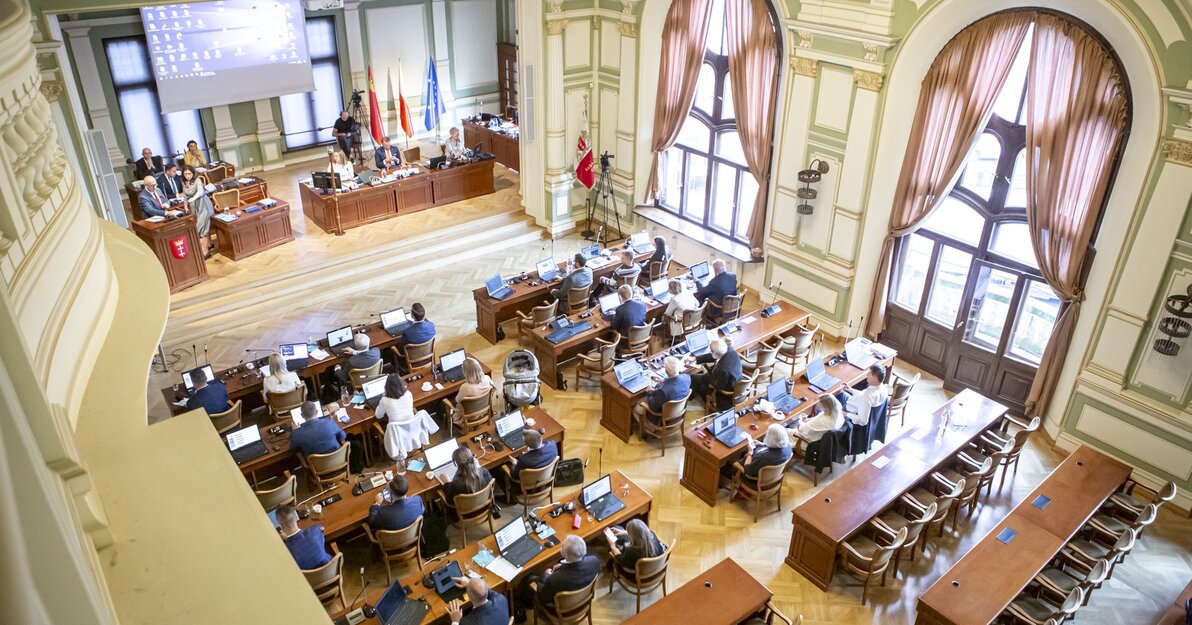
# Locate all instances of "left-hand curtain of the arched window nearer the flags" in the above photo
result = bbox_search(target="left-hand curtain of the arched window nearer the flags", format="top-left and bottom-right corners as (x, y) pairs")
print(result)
(645, 0), (712, 200)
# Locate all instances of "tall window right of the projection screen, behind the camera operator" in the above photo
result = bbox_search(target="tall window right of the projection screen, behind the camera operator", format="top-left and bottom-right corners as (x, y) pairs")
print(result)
(280, 16), (343, 150)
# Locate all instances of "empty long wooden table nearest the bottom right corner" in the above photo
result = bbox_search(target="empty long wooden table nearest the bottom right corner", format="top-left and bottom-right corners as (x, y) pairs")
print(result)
(914, 446), (1130, 625)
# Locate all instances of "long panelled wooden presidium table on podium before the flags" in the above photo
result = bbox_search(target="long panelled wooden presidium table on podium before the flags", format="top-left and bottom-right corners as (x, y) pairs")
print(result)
(298, 160), (495, 234)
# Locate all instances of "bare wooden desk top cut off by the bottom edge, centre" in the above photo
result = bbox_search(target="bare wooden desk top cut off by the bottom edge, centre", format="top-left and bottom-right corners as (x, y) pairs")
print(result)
(623, 558), (774, 625)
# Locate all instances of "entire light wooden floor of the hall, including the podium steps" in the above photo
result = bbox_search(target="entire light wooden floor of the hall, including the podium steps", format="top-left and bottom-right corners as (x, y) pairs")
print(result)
(148, 161), (1192, 625)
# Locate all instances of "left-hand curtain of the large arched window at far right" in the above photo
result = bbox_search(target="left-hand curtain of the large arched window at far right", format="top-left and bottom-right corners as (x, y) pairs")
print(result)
(865, 11), (1035, 336)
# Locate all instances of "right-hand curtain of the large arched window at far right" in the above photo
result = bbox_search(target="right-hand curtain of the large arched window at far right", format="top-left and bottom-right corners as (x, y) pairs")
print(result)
(1026, 14), (1128, 415)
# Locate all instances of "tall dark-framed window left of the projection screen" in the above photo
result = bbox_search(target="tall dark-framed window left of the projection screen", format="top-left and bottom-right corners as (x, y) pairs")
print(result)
(104, 36), (207, 159)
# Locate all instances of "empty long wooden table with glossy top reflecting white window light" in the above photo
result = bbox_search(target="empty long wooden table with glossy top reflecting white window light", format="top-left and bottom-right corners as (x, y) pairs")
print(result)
(786, 389), (1007, 590)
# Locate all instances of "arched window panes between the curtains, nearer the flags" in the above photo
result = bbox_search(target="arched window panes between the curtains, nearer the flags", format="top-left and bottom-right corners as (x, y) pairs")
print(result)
(658, 0), (772, 242)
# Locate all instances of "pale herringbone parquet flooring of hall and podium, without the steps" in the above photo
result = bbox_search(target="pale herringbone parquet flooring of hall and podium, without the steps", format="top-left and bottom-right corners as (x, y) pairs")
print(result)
(148, 159), (1192, 625)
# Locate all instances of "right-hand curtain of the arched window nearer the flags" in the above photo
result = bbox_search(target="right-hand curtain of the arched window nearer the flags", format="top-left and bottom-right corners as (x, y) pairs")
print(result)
(725, 0), (778, 254)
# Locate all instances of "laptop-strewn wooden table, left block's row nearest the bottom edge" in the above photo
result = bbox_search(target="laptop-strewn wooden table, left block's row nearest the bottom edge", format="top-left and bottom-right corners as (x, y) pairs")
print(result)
(324, 471), (653, 624)
